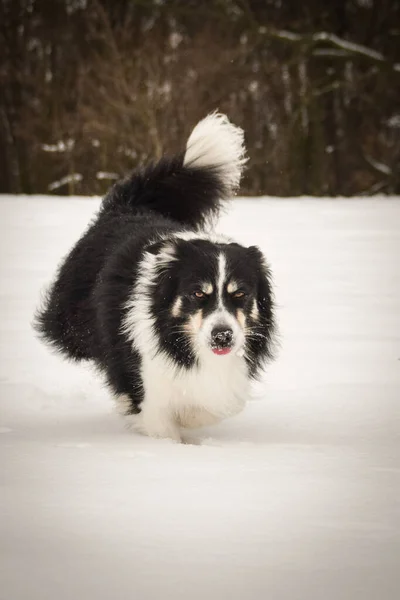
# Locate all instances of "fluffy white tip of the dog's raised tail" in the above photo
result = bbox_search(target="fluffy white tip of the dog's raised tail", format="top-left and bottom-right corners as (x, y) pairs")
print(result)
(184, 112), (247, 195)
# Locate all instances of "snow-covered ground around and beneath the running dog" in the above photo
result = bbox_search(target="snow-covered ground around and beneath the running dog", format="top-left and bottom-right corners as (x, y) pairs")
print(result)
(0, 196), (400, 600)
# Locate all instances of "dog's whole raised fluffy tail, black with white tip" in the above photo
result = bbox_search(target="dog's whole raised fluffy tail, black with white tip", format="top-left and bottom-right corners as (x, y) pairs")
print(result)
(103, 113), (247, 227)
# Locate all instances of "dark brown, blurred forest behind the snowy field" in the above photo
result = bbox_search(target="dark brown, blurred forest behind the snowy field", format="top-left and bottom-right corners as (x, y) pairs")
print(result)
(0, 0), (400, 196)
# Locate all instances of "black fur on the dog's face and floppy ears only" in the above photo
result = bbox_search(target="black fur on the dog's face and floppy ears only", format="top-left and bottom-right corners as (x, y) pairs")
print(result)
(152, 239), (275, 377)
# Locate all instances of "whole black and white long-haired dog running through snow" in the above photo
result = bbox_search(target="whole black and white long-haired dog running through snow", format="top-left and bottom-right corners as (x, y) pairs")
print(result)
(35, 113), (274, 440)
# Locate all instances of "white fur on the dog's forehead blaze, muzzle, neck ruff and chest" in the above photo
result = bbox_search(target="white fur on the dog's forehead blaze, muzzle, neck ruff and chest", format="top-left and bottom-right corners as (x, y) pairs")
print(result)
(120, 245), (249, 441)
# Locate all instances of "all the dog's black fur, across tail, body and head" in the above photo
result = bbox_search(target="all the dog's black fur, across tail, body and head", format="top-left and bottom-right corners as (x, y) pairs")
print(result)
(35, 148), (273, 413)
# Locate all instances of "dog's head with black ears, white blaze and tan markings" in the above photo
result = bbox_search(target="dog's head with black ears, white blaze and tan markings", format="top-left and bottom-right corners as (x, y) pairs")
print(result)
(134, 236), (274, 374)
